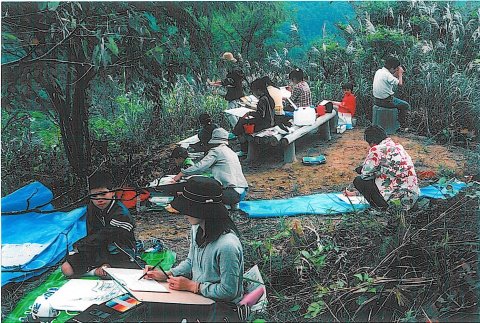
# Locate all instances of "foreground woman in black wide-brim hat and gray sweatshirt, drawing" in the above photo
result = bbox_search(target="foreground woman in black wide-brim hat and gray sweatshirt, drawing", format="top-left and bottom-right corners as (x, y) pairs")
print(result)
(144, 176), (244, 322)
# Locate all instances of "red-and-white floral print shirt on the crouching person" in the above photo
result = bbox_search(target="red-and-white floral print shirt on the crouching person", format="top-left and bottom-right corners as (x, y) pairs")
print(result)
(361, 138), (420, 210)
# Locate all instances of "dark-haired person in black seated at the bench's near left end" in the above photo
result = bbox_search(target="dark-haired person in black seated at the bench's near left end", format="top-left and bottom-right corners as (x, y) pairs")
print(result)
(233, 78), (275, 154)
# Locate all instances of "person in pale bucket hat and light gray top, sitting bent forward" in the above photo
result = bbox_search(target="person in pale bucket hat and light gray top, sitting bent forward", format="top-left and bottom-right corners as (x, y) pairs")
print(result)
(173, 128), (248, 208)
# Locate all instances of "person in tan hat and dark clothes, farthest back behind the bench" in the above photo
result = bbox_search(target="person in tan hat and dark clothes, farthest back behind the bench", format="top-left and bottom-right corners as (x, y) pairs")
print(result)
(209, 52), (244, 127)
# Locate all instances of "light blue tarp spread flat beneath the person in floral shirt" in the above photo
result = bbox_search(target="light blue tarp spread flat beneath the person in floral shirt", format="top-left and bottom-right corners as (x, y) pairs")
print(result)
(240, 182), (466, 218)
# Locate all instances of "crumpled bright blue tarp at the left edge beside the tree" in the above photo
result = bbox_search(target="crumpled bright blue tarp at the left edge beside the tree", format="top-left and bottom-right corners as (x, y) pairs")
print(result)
(1, 182), (87, 286)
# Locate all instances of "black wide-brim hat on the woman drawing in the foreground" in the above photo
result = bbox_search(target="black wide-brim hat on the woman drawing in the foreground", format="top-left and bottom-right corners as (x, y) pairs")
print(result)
(170, 176), (228, 219)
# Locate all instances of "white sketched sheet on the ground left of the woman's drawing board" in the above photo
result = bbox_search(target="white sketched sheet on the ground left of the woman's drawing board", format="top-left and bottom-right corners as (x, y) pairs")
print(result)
(48, 279), (125, 311)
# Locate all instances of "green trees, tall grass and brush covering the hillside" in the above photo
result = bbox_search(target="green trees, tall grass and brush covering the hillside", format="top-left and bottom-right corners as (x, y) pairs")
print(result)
(1, 1), (480, 321)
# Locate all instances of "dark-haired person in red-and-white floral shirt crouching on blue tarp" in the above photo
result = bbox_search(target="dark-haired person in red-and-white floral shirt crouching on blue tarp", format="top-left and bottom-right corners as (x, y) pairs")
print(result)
(353, 126), (420, 210)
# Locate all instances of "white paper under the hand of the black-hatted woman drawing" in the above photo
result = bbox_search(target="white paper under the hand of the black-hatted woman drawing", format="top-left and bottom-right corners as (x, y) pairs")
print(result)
(105, 268), (168, 293)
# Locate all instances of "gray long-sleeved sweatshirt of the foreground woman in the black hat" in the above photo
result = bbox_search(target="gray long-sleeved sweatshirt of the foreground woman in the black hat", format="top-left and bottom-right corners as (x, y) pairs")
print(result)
(170, 225), (244, 304)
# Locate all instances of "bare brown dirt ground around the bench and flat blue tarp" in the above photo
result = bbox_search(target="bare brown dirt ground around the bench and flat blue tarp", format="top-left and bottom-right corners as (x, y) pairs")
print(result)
(136, 127), (467, 258)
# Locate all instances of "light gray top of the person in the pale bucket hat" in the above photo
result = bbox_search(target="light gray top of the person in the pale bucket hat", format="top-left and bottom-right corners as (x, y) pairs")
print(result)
(182, 144), (248, 188)
